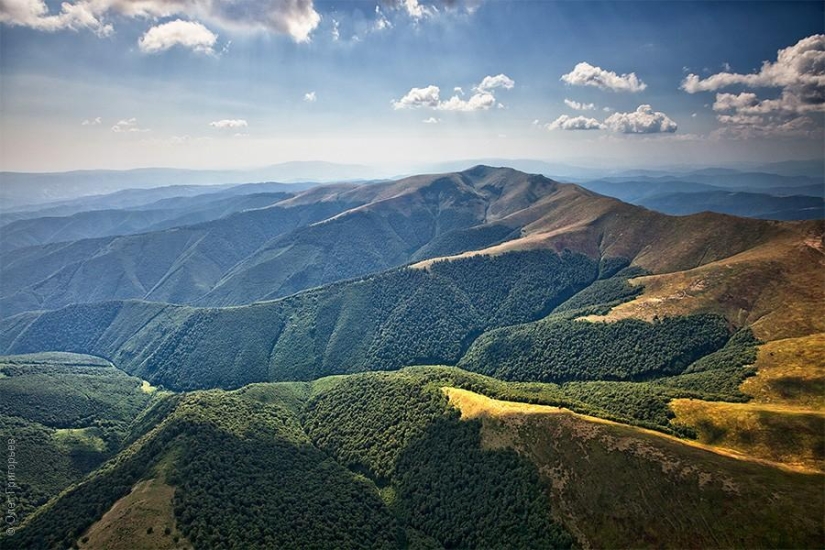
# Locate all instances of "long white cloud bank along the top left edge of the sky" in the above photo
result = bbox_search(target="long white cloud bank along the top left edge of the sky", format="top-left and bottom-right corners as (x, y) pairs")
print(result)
(0, 0), (321, 42)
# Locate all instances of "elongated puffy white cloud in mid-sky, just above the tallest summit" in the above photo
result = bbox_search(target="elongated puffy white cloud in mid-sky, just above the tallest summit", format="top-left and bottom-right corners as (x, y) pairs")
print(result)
(392, 74), (515, 112)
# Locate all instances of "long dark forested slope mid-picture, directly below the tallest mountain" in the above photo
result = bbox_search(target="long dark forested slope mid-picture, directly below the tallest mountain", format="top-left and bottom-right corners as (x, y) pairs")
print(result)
(0, 251), (599, 389)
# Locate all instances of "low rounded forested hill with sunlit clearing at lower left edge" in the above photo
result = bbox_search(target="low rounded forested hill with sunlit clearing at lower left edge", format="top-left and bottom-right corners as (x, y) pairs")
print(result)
(0, 353), (156, 521)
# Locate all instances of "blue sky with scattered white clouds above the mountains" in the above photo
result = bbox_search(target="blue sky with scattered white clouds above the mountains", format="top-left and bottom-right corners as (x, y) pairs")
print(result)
(0, 0), (825, 172)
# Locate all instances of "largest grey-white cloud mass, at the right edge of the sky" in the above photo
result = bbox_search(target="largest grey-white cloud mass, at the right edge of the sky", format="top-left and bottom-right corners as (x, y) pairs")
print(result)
(681, 34), (825, 138)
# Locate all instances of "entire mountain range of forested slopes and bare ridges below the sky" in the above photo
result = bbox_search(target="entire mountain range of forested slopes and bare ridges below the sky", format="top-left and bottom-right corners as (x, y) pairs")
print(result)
(0, 165), (825, 548)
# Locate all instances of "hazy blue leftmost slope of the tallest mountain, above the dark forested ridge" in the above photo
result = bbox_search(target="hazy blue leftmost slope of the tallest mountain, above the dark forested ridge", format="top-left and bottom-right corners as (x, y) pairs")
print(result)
(0, 196), (358, 315)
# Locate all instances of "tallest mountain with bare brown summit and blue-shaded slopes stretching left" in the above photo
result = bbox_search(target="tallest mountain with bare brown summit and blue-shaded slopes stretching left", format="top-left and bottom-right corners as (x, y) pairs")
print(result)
(0, 167), (808, 316)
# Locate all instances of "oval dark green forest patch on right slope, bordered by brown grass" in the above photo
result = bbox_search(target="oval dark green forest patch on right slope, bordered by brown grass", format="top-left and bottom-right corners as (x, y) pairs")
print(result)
(459, 315), (730, 382)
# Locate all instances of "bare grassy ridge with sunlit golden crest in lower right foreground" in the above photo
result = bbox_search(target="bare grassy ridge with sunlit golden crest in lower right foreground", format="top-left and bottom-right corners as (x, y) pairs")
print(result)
(445, 388), (825, 548)
